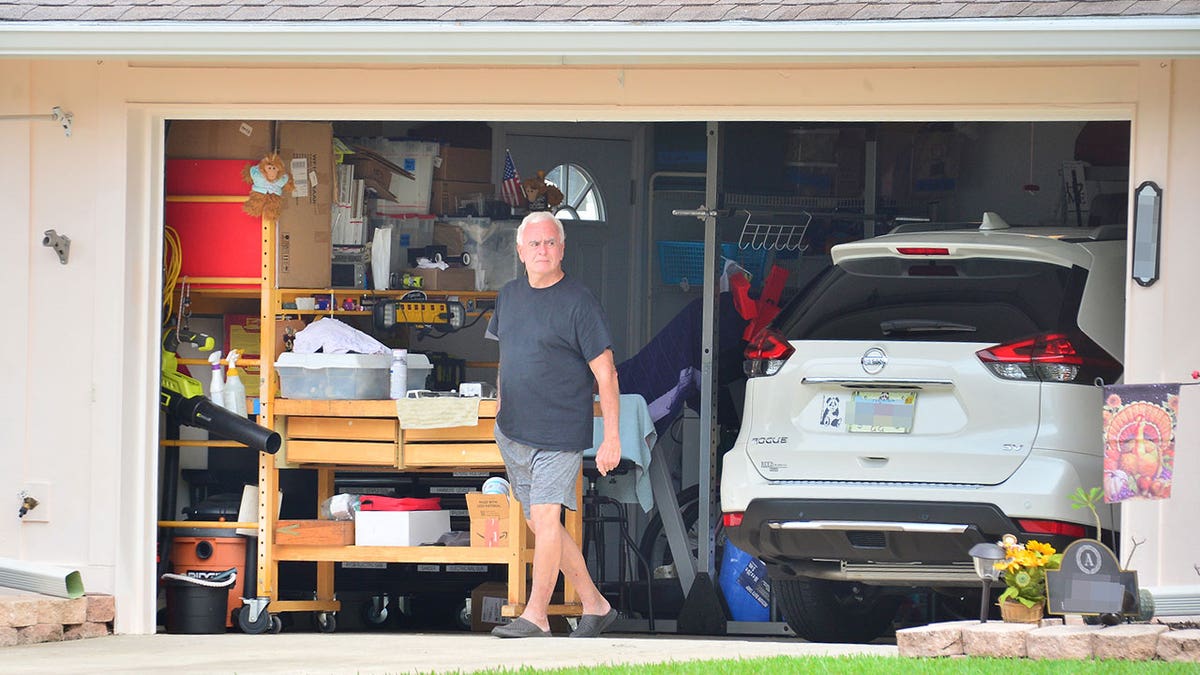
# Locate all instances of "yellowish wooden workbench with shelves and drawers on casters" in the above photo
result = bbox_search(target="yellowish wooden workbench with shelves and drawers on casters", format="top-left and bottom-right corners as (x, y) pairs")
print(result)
(241, 219), (582, 629)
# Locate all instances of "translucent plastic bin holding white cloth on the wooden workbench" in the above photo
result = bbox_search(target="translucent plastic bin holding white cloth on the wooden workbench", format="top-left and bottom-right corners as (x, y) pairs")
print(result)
(275, 352), (391, 400)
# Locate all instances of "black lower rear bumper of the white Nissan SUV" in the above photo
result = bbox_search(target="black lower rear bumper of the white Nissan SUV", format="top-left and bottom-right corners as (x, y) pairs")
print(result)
(725, 498), (1072, 585)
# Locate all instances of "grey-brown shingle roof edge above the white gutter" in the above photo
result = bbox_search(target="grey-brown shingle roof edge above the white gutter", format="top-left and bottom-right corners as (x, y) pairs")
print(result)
(0, 0), (1200, 23)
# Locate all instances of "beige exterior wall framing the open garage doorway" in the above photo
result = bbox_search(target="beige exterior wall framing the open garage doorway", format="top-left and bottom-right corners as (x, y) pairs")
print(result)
(0, 60), (1200, 632)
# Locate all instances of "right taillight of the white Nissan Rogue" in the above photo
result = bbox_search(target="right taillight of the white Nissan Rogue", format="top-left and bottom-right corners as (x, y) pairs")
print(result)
(976, 333), (1122, 384)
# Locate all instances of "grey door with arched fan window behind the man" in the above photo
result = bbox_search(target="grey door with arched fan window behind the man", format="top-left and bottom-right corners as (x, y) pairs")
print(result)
(500, 133), (640, 363)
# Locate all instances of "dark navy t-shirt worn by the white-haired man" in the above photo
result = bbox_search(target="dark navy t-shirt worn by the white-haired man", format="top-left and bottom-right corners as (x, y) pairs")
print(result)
(486, 276), (612, 452)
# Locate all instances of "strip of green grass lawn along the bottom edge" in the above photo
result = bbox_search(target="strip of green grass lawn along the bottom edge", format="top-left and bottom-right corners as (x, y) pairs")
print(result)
(458, 656), (1200, 675)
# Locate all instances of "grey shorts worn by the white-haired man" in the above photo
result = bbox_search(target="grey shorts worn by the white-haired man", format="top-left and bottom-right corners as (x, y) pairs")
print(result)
(496, 426), (583, 518)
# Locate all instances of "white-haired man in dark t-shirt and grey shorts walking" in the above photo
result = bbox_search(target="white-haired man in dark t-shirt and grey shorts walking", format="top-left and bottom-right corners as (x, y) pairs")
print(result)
(486, 211), (620, 638)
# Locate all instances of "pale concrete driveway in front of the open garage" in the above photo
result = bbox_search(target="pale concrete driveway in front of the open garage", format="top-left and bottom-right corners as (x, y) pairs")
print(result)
(0, 632), (896, 675)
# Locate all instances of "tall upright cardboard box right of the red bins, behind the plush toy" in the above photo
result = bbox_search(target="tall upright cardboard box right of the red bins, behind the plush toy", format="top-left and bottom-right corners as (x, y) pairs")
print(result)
(275, 121), (335, 288)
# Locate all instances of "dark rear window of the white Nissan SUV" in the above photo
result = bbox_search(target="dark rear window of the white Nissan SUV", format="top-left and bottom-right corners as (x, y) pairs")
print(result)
(775, 257), (1087, 342)
